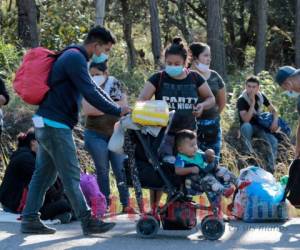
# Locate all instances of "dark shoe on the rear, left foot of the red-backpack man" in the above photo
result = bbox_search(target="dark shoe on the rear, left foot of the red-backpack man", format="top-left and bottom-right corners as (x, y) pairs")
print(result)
(21, 218), (56, 234)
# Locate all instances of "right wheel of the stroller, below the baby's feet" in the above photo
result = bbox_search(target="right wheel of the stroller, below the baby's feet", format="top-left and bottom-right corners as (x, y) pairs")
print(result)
(201, 215), (225, 240)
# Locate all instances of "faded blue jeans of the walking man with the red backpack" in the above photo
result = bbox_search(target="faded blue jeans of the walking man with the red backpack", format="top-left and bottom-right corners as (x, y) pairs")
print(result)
(23, 126), (91, 222)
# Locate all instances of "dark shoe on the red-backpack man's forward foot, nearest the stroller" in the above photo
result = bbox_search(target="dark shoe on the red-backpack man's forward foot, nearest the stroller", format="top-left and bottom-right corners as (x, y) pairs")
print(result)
(81, 217), (116, 235)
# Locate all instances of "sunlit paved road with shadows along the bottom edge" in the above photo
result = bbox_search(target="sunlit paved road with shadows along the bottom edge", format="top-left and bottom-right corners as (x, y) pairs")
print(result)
(0, 215), (300, 250)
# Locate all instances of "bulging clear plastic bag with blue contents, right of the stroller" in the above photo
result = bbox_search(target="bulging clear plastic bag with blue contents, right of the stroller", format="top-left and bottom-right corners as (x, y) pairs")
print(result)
(232, 166), (288, 222)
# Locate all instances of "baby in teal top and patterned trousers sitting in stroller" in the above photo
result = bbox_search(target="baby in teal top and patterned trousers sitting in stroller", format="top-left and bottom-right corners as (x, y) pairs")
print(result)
(175, 129), (250, 201)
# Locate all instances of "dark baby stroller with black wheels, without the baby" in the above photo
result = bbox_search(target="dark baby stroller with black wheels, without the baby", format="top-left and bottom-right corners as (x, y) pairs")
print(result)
(124, 113), (225, 240)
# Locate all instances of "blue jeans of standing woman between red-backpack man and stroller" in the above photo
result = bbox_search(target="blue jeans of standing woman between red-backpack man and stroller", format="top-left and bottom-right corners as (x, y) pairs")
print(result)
(84, 129), (129, 206)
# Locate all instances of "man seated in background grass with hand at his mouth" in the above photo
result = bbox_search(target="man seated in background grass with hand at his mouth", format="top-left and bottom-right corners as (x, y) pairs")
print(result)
(237, 76), (278, 173)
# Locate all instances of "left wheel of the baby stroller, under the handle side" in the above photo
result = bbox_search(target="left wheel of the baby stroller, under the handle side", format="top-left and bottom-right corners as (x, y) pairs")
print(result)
(136, 215), (159, 238)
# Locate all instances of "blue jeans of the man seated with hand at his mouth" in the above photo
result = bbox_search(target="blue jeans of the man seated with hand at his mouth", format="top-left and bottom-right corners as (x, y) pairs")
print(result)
(241, 122), (278, 173)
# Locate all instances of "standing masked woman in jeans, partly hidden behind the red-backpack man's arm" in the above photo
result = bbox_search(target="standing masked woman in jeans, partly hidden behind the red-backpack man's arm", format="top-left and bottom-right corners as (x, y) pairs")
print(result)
(82, 61), (136, 214)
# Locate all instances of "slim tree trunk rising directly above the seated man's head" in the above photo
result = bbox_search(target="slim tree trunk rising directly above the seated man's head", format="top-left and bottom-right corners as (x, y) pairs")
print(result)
(254, 0), (268, 74)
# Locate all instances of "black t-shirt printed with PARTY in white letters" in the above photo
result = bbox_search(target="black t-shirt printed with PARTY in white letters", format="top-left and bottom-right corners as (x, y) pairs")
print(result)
(148, 71), (205, 132)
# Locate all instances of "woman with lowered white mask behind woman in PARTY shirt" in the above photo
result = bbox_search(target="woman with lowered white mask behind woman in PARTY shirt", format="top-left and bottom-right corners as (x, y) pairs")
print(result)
(189, 42), (226, 159)
